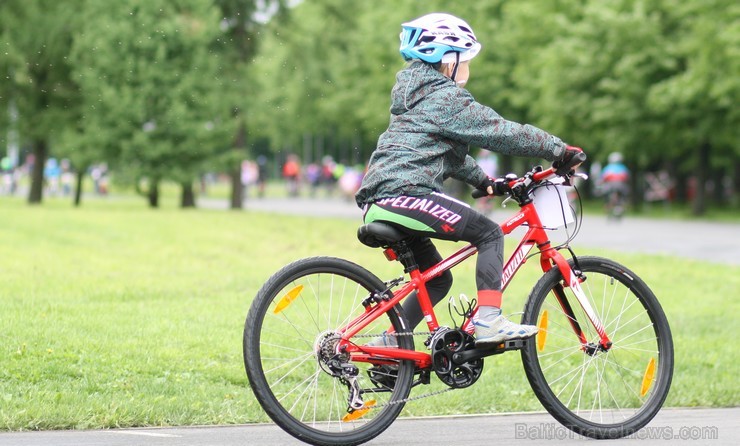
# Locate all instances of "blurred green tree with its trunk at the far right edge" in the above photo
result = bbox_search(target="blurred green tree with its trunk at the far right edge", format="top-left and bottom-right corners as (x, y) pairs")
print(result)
(646, 0), (740, 215)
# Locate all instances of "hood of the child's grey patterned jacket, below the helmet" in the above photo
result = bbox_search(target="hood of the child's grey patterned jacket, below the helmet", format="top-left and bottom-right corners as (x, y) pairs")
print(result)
(391, 62), (457, 115)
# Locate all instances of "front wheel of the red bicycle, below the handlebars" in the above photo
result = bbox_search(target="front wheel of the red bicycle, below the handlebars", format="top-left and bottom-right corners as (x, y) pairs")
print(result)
(522, 257), (673, 439)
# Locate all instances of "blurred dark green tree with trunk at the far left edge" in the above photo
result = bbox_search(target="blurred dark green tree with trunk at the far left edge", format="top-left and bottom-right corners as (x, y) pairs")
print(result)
(0, 0), (80, 204)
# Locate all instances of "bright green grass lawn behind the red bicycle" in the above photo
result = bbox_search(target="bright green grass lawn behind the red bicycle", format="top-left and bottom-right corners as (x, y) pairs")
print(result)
(0, 197), (740, 430)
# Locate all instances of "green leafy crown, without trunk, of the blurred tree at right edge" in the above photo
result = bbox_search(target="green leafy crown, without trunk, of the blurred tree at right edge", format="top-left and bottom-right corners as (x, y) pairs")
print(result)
(647, 0), (740, 154)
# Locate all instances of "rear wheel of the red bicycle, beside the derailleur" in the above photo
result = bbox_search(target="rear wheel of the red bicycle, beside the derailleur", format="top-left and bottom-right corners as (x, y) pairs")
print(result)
(243, 257), (414, 445)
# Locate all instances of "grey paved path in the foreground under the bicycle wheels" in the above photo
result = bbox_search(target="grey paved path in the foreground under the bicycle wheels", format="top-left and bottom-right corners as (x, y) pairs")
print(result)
(0, 408), (740, 446)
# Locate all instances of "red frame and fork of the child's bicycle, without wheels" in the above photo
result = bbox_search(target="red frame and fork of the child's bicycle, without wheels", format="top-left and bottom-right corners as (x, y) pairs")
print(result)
(338, 173), (611, 368)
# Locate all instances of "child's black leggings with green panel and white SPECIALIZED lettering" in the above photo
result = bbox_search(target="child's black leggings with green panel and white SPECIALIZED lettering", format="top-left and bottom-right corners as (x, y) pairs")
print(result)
(365, 193), (504, 327)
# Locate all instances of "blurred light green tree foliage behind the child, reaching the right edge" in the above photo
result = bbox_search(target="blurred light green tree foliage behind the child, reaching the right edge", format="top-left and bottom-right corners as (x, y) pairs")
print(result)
(254, 0), (740, 201)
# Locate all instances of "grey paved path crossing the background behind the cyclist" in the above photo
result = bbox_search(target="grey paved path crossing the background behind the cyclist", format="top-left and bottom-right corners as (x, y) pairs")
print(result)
(199, 198), (740, 265)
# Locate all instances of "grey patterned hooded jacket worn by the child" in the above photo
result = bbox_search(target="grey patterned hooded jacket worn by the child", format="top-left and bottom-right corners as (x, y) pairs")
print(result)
(355, 62), (565, 206)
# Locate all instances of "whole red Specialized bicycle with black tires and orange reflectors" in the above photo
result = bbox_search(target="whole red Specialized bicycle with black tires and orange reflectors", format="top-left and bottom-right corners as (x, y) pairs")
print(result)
(244, 160), (673, 445)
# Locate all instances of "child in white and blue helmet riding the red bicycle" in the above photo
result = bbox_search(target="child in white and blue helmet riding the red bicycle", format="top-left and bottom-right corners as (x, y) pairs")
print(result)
(355, 13), (581, 345)
